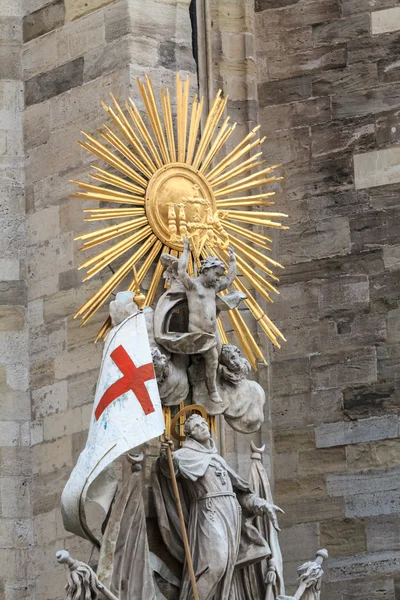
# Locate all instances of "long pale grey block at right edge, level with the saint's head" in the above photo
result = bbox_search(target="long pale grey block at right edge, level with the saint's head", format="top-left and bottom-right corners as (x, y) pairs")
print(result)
(315, 415), (399, 448)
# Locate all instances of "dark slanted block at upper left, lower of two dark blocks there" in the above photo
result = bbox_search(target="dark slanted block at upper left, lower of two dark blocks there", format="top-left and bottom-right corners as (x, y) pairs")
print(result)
(25, 58), (84, 106)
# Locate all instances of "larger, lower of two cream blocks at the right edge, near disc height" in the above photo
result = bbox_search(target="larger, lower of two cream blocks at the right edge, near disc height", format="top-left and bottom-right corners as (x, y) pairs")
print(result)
(354, 146), (400, 189)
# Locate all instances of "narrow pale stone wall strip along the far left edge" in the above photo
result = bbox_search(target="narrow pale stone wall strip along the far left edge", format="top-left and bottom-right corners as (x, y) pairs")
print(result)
(0, 0), (32, 600)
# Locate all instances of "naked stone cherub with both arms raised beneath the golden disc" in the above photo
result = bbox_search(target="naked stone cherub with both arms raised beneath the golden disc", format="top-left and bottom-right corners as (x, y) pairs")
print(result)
(178, 237), (236, 403)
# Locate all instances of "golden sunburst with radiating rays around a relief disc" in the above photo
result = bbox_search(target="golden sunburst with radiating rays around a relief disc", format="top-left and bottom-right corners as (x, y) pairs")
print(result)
(73, 74), (287, 368)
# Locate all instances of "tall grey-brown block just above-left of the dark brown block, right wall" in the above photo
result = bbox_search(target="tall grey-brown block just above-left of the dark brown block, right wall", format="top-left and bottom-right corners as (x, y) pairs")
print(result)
(311, 347), (377, 389)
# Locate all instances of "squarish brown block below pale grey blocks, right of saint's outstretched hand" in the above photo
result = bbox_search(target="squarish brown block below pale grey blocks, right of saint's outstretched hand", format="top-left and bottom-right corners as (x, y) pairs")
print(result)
(320, 519), (367, 557)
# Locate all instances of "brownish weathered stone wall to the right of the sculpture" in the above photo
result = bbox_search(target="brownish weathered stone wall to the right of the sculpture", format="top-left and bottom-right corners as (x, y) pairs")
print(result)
(256, 0), (400, 600)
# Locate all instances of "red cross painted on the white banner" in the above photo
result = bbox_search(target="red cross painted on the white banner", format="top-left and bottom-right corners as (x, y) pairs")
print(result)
(94, 345), (155, 421)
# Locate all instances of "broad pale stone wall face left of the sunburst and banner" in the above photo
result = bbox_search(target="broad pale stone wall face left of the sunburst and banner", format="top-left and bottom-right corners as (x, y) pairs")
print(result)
(21, 0), (196, 600)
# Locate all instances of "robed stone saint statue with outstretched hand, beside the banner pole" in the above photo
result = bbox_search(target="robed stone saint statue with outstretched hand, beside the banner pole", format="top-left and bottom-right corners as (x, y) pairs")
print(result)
(153, 415), (283, 600)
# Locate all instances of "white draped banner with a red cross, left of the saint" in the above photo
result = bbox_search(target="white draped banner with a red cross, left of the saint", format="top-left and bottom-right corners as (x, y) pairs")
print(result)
(61, 312), (165, 542)
